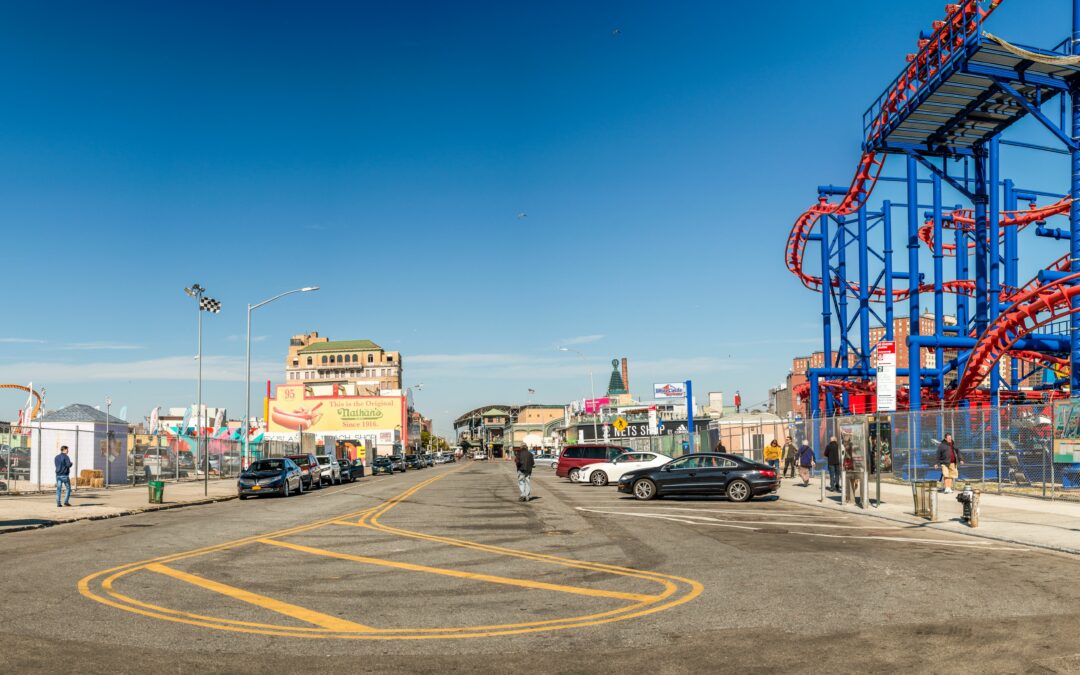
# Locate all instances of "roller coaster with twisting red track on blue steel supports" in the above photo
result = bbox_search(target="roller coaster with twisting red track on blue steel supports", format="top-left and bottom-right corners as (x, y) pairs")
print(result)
(785, 0), (1080, 417)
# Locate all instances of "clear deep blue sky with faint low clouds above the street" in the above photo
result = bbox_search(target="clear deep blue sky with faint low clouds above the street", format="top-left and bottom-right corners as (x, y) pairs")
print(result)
(0, 0), (1068, 431)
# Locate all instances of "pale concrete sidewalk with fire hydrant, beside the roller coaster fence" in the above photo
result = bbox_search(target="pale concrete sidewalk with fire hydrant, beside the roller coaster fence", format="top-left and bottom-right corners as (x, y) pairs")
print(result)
(780, 475), (1080, 555)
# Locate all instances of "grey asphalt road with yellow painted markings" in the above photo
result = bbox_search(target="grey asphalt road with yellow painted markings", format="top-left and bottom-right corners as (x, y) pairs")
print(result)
(6, 461), (1080, 673)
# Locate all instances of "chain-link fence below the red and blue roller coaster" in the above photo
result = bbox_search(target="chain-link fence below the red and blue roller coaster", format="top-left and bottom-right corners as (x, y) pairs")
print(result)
(789, 404), (1080, 500)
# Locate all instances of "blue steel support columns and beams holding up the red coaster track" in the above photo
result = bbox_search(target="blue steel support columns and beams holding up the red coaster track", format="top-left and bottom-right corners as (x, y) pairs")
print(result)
(793, 0), (1080, 421)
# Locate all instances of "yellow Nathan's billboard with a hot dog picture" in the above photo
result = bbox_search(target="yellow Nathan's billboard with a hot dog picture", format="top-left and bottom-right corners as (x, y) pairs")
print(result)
(268, 384), (407, 433)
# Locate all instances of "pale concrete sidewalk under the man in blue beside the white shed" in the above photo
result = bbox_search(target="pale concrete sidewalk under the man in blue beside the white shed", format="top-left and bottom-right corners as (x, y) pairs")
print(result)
(0, 480), (237, 534)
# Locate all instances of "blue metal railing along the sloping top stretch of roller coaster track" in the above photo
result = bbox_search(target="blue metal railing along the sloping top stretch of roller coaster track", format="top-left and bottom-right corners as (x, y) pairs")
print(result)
(863, 2), (983, 152)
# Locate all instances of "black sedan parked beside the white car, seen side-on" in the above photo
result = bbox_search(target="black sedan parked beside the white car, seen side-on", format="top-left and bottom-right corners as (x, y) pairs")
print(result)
(619, 453), (780, 501)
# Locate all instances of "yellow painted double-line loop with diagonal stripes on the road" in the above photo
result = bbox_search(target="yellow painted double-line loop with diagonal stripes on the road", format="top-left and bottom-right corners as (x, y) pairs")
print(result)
(79, 469), (703, 640)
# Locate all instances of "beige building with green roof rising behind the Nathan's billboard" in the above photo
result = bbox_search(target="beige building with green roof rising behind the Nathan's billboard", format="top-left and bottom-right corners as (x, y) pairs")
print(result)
(285, 332), (402, 390)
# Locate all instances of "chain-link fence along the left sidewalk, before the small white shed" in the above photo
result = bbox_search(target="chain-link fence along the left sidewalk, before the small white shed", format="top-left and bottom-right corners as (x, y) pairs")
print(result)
(0, 422), (299, 494)
